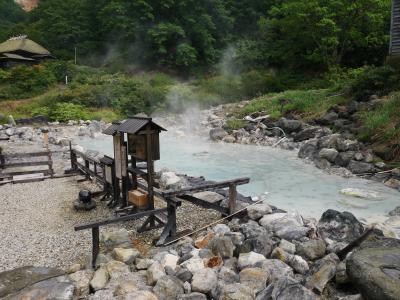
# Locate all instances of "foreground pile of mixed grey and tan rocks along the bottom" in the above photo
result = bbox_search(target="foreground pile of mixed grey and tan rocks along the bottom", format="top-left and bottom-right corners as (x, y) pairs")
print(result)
(0, 203), (400, 300)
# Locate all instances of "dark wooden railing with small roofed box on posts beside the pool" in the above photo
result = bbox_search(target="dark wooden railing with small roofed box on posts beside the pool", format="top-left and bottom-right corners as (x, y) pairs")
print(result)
(71, 117), (251, 268)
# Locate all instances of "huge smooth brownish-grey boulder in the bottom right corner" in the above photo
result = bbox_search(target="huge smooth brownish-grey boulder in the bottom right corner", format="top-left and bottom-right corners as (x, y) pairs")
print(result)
(346, 237), (400, 300)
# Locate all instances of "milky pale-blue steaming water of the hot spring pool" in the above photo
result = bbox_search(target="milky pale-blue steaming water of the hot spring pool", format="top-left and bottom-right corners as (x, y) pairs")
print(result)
(78, 131), (400, 220)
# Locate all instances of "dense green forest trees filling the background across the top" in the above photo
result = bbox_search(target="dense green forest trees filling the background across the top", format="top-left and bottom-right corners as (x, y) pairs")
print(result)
(0, 0), (391, 74)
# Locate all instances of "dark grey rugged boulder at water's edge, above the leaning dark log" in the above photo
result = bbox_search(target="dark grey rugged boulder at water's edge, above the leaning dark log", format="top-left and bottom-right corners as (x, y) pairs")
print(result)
(317, 209), (364, 242)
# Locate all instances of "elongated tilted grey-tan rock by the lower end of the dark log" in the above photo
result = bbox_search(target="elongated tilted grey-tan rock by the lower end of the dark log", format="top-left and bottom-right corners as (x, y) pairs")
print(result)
(306, 253), (339, 294)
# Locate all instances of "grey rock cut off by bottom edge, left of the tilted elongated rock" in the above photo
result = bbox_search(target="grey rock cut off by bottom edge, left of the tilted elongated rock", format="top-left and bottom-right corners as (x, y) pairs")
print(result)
(272, 277), (318, 300)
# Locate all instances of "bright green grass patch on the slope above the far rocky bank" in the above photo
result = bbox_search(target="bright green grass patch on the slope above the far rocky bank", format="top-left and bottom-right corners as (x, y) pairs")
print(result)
(237, 89), (348, 121)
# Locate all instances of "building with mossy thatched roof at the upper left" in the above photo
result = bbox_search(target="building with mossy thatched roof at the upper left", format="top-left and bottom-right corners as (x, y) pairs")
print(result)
(0, 35), (55, 68)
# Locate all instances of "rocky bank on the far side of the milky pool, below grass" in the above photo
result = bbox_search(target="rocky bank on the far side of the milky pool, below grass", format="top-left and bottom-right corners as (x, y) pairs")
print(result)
(204, 99), (400, 191)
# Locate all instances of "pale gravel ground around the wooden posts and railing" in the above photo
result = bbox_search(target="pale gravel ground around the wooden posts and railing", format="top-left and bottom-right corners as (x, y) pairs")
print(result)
(0, 177), (220, 272)
